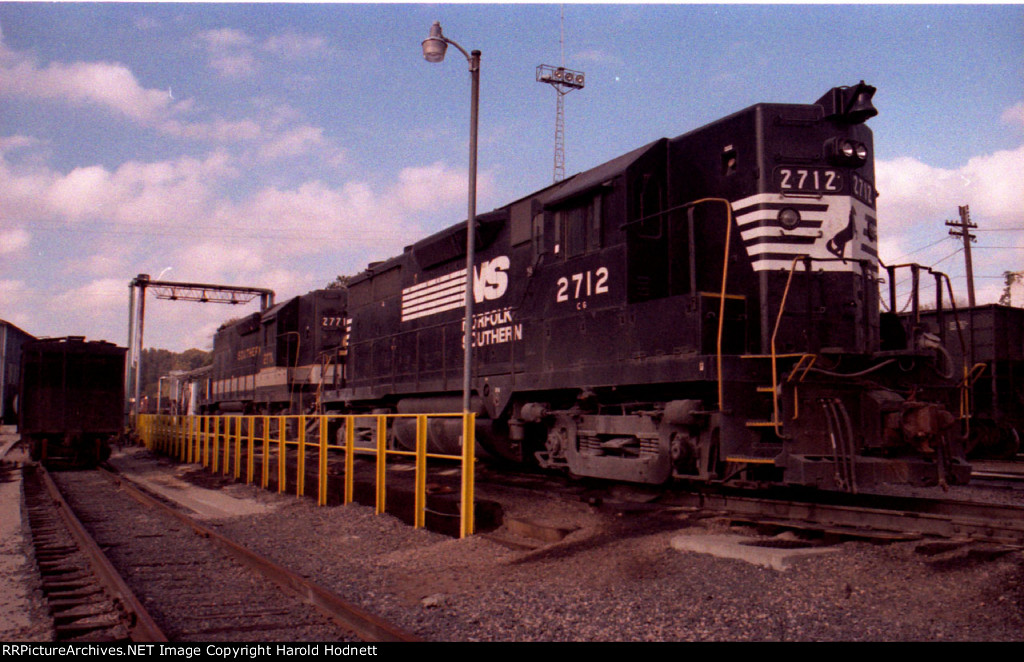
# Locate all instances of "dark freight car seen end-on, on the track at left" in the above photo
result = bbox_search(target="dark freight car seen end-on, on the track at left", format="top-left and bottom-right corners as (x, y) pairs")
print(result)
(18, 336), (127, 467)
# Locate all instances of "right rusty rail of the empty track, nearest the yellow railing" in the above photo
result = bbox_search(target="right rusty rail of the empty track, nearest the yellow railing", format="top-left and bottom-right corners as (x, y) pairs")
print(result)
(93, 469), (421, 642)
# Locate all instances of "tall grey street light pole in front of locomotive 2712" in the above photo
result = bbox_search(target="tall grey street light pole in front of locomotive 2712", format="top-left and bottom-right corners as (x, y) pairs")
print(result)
(423, 20), (480, 415)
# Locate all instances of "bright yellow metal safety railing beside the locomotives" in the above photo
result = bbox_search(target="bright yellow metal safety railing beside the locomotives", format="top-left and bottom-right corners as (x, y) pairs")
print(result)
(135, 414), (476, 537)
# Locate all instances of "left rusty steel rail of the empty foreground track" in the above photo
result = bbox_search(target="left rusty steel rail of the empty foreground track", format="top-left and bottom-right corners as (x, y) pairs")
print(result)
(34, 464), (168, 642)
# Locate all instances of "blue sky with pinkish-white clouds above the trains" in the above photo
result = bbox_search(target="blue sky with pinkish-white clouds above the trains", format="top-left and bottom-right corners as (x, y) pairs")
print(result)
(0, 2), (1024, 350)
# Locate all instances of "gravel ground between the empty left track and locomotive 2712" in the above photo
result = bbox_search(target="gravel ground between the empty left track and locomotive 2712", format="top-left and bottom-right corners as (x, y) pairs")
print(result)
(116, 452), (1024, 642)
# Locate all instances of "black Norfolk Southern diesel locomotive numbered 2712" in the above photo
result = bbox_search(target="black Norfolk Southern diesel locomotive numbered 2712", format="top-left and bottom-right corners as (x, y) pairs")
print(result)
(197, 82), (970, 490)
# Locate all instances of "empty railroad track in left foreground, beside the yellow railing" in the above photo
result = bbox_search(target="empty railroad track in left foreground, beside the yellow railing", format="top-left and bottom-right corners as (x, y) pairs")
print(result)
(26, 470), (416, 643)
